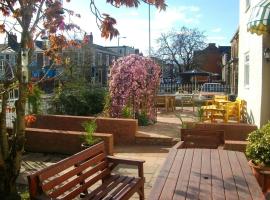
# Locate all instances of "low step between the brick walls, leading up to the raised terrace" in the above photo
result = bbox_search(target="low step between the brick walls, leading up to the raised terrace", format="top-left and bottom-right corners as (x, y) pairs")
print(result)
(135, 131), (180, 146)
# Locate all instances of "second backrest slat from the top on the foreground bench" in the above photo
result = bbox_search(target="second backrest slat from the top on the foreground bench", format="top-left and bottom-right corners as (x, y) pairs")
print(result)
(42, 153), (107, 191)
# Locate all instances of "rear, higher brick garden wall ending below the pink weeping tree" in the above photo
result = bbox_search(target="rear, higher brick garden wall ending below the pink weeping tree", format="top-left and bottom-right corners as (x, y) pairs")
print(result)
(30, 115), (138, 145)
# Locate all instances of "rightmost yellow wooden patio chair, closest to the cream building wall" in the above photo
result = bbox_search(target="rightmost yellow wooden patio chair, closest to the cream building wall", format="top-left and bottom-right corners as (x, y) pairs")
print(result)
(224, 101), (241, 123)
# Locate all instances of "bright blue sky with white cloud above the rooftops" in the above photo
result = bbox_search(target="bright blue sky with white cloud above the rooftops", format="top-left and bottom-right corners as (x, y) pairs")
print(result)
(62, 0), (239, 55)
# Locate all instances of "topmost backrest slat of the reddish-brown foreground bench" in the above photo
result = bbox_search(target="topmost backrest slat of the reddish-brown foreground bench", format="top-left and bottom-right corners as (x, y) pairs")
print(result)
(38, 143), (104, 181)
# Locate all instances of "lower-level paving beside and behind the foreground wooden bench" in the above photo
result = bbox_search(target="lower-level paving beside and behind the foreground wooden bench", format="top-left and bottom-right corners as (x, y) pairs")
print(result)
(20, 145), (169, 200)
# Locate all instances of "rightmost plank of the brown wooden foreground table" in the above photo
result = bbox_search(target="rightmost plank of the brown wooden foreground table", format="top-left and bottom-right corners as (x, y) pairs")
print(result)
(236, 152), (265, 200)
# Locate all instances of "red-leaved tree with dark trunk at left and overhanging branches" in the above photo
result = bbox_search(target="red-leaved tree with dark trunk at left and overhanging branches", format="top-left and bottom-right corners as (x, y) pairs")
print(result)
(0, 0), (166, 200)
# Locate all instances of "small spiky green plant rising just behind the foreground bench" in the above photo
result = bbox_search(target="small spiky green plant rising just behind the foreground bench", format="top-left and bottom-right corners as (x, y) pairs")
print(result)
(82, 120), (100, 146)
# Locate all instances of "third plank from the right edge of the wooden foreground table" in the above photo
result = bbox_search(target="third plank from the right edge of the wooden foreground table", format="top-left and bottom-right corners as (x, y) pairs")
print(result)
(219, 150), (239, 200)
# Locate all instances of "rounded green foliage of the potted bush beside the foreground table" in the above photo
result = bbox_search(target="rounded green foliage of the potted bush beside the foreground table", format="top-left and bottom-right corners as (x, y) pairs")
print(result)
(246, 122), (270, 166)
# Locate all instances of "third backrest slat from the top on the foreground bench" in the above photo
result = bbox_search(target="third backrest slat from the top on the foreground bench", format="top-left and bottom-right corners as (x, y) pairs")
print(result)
(48, 162), (110, 198)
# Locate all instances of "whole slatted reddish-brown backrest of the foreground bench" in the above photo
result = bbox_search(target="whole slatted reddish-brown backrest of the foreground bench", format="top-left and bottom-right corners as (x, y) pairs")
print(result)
(28, 142), (107, 199)
